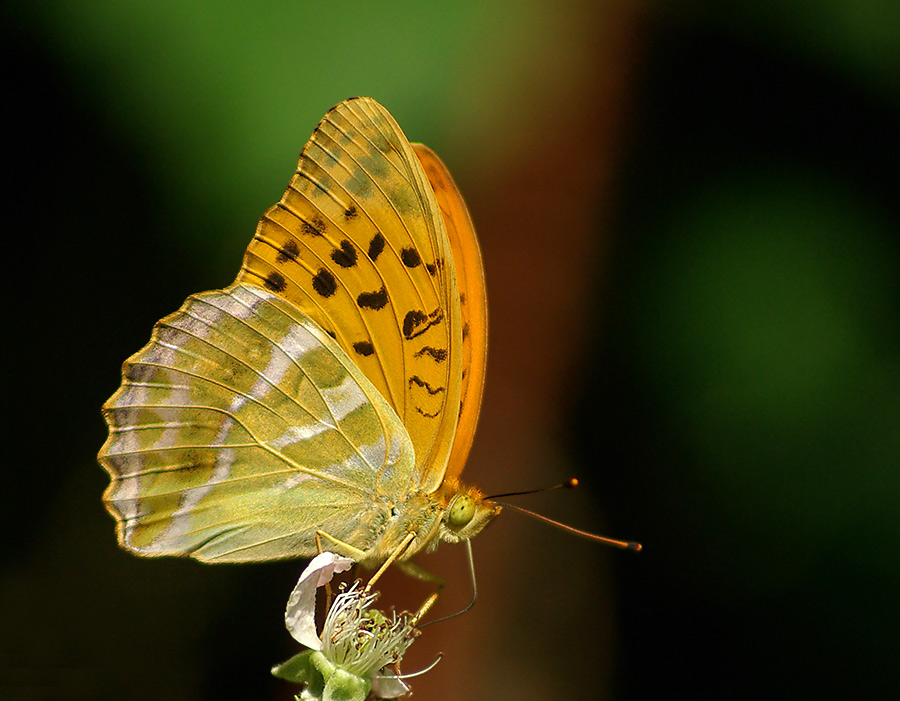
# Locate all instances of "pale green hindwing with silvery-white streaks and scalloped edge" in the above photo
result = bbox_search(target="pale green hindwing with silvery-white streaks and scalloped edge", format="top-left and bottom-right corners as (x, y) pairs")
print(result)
(100, 284), (416, 562)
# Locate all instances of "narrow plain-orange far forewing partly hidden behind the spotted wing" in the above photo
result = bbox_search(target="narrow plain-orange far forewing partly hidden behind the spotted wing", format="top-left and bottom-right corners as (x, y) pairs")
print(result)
(412, 144), (487, 491)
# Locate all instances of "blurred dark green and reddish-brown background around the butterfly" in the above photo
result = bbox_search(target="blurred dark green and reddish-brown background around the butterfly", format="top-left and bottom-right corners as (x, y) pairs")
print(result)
(0, 0), (900, 701)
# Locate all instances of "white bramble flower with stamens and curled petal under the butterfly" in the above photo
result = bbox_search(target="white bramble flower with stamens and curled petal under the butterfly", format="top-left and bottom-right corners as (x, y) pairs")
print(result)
(272, 552), (417, 701)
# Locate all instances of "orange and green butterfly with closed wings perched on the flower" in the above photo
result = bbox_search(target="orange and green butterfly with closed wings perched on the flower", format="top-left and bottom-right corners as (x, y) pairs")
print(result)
(99, 97), (501, 567)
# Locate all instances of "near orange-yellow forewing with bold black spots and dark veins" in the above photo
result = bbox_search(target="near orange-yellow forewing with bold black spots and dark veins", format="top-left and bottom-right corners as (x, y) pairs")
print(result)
(238, 98), (464, 492)
